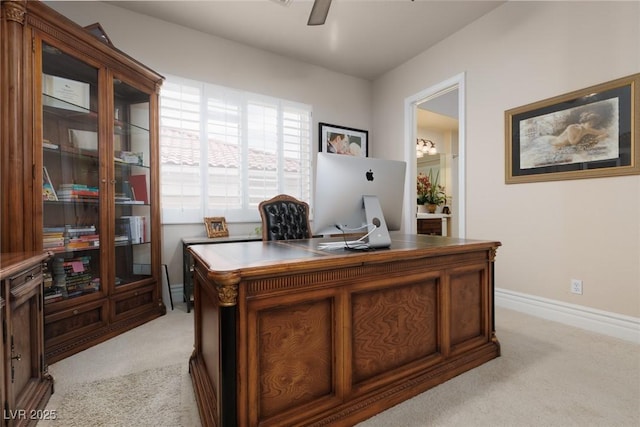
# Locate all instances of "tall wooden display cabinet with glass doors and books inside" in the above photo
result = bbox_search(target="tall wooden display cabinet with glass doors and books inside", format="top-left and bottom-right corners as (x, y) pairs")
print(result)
(1, 1), (166, 363)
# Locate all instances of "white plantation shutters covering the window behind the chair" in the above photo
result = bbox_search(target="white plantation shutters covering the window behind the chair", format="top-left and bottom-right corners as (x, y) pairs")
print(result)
(160, 76), (312, 223)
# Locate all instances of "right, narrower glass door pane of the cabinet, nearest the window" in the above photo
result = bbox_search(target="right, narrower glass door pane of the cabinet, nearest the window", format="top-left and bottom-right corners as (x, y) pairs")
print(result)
(113, 79), (154, 289)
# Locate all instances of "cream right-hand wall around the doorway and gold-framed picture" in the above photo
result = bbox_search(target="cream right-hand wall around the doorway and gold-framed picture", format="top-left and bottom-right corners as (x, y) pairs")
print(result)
(372, 2), (640, 317)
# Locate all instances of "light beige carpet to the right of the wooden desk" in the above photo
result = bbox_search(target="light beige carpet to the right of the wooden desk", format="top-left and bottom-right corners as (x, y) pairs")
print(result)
(358, 307), (640, 427)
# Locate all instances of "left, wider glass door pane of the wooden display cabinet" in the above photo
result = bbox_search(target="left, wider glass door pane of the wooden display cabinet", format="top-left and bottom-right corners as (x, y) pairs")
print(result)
(42, 43), (104, 304)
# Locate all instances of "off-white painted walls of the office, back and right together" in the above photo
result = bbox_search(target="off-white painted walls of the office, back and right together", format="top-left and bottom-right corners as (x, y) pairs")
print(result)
(49, 2), (640, 317)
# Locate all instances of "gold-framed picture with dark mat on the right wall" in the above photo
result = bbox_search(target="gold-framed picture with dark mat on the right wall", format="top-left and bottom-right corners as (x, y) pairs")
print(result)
(505, 74), (640, 184)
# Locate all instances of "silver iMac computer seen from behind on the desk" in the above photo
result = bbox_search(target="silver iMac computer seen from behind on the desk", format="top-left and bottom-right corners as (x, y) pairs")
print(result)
(312, 153), (407, 248)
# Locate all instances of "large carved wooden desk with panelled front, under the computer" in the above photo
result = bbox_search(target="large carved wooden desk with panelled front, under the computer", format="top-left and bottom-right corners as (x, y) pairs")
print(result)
(189, 235), (500, 426)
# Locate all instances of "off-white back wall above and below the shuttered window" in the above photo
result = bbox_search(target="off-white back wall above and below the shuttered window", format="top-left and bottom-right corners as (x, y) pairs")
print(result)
(47, 1), (372, 283)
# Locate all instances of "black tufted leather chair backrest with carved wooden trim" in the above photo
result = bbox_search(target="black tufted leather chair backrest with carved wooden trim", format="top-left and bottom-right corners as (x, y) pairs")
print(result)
(258, 194), (311, 240)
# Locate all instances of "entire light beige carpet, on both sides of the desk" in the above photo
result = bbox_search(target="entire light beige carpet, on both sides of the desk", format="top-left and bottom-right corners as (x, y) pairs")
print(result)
(38, 305), (640, 427)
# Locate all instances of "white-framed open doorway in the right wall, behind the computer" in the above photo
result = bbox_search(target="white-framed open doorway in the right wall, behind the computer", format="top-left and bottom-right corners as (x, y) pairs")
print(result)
(404, 73), (466, 238)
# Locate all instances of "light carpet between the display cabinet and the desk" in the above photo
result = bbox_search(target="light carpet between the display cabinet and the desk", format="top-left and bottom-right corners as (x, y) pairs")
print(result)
(38, 304), (201, 427)
